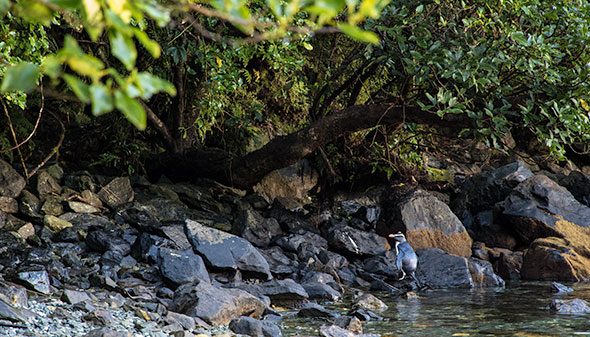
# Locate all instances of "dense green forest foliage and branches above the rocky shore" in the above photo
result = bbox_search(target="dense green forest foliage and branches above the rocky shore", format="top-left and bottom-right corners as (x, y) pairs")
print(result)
(0, 0), (590, 187)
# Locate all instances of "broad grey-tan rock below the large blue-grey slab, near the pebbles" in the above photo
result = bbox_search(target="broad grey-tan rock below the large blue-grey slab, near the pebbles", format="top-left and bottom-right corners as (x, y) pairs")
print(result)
(170, 282), (265, 325)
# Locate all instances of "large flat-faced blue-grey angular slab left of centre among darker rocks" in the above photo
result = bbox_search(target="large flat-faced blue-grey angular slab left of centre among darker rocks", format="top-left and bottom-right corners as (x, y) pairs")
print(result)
(185, 220), (272, 280)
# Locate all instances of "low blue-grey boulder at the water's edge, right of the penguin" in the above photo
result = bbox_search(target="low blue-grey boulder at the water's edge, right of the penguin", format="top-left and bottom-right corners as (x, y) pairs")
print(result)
(416, 248), (504, 288)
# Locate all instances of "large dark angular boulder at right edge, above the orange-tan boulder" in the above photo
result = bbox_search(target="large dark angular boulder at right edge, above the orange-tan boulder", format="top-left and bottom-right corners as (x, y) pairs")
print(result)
(500, 175), (590, 243)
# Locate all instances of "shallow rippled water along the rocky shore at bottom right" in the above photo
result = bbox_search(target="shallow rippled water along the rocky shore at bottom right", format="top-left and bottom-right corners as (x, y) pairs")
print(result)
(283, 282), (590, 336)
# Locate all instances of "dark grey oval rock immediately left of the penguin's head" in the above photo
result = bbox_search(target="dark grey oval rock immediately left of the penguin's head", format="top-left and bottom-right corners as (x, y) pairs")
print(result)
(326, 225), (391, 256)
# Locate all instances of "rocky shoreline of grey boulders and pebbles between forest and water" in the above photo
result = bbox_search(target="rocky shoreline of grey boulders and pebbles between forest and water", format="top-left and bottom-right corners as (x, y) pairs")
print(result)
(0, 161), (590, 337)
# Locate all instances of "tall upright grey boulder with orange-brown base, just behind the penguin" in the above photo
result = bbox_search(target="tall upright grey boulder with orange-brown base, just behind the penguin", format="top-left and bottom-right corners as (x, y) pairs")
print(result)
(389, 189), (472, 256)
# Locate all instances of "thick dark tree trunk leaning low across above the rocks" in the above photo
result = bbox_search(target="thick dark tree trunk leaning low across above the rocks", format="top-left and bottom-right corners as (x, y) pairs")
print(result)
(154, 104), (473, 188)
